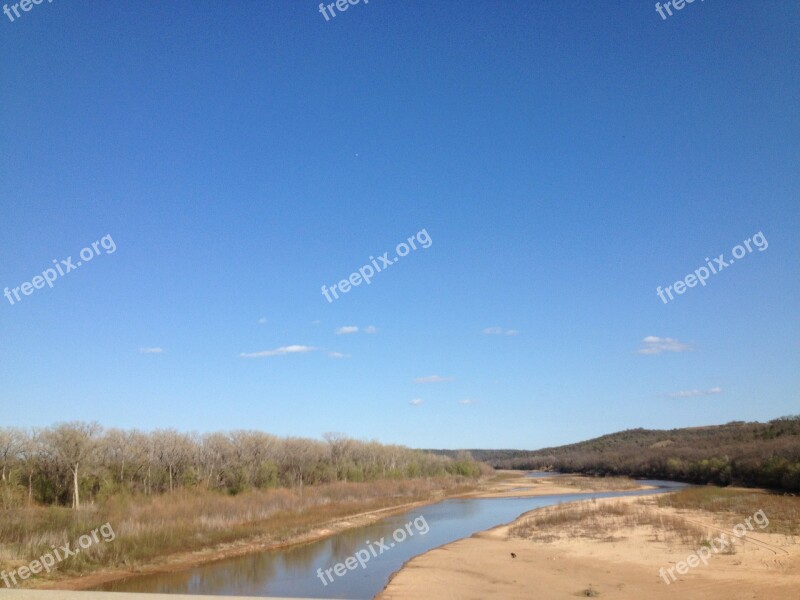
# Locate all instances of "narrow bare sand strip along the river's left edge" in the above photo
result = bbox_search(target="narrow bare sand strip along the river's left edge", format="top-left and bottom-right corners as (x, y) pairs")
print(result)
(20, 471), (643, 590)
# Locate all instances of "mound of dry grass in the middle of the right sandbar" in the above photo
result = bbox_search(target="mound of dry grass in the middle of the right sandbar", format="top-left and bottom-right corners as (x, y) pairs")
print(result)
(509, 500), (706, 545)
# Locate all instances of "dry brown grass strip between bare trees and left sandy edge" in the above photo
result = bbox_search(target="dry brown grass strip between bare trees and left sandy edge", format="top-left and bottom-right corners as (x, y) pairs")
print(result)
(0, 477), (475, 574)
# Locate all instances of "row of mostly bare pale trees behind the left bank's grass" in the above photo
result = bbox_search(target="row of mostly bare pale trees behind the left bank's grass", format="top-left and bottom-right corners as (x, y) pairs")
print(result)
(0, 422), (489, 509)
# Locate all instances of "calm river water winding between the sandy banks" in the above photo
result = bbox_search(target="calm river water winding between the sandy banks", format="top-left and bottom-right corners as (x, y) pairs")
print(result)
(96, 474), (684, 600)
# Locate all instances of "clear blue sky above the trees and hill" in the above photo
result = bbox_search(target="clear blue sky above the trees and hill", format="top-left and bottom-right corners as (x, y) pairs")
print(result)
(0, 0), (800, 448)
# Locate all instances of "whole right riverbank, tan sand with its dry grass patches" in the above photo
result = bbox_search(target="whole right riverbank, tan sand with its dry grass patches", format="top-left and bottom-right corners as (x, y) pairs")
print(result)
(378, 490), (800, 600)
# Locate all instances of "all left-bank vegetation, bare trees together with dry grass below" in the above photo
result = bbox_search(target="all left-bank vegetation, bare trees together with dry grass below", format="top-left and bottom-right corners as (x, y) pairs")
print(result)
(0, 423), (493, 577)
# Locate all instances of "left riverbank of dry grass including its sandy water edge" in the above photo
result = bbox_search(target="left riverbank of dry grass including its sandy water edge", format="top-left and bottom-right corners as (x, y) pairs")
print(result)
(0, 477), (479, 590)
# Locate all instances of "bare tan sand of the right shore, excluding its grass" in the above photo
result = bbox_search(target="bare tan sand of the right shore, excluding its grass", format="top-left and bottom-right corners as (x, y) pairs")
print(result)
(378, 482), (800, 600)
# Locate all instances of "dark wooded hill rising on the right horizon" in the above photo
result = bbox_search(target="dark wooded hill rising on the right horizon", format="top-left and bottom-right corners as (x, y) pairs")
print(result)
(431, 415), (800, 491)
